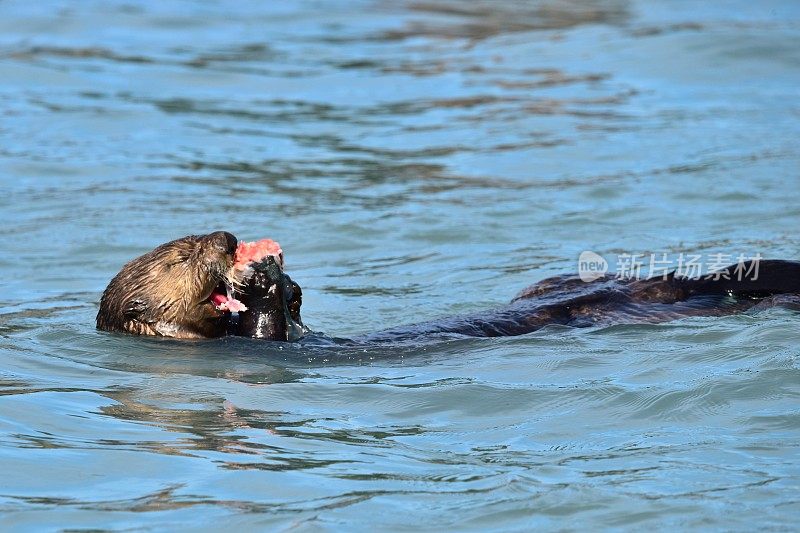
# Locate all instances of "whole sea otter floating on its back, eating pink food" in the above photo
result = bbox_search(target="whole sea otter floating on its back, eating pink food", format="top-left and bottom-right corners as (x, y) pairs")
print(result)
(97, 231), (800, 343)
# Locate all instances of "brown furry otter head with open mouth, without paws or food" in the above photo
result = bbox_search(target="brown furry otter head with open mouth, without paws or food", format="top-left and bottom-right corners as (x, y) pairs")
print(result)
(97, 231), (237, 338)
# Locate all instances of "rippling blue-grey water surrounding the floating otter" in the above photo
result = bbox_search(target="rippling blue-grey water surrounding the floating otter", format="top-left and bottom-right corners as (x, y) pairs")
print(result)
(0, 0), (800, 530)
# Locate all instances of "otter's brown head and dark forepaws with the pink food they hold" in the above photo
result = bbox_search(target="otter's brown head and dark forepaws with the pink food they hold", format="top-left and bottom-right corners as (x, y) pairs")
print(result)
(97, 231), (305, 340)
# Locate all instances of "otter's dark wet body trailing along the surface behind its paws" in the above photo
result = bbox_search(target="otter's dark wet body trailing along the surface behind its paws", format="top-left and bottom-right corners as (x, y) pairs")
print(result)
(358, 260), (800, 343)
